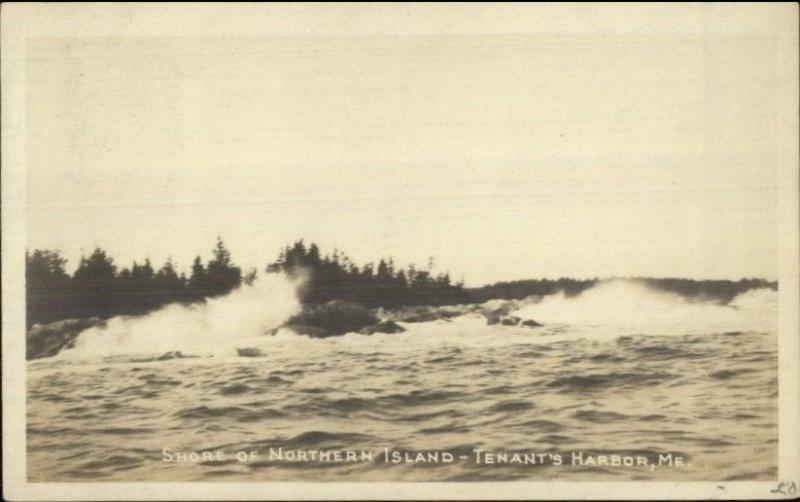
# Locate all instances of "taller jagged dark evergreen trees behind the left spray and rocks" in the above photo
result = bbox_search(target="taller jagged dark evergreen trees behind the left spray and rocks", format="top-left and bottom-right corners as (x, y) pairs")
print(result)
(25, 239), (469, 327)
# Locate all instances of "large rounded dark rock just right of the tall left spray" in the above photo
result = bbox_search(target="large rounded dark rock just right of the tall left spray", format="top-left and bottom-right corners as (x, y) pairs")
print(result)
(282, 300), (380, 338)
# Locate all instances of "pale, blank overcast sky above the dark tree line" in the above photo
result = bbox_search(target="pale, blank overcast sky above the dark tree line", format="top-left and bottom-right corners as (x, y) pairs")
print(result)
(26, 29), (780, 285)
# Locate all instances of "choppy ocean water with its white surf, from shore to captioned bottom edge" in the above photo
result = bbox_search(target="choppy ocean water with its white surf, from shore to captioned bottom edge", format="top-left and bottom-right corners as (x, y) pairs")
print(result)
(27, 282), (778, 481)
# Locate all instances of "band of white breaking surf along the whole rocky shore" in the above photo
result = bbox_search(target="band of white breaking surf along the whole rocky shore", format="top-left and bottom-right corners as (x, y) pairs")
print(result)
(59, 274), (777, 360)
